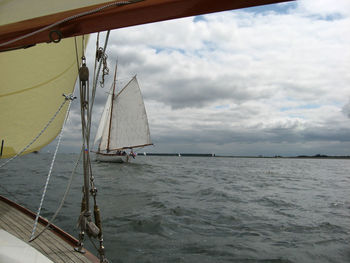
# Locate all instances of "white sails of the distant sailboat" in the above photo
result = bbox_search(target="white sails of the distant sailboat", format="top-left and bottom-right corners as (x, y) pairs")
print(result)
(100, 76), (152, 151)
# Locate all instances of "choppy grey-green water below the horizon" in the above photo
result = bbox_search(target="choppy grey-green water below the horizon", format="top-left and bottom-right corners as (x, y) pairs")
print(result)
(0, 154), (350, 263)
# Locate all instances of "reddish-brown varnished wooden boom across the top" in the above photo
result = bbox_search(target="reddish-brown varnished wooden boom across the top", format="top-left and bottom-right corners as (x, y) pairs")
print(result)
(0, 0), (294, 51)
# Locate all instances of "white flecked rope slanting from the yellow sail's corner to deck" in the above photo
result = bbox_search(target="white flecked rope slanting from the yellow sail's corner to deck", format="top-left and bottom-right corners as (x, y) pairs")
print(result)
(30, 94), (75, 239)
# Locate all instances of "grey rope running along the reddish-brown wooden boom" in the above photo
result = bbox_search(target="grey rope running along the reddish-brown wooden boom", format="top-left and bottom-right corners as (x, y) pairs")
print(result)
(0, 0), (144, 47)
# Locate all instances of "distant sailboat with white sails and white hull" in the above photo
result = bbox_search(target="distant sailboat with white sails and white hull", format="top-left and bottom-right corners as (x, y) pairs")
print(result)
(95, 66), (152, 163)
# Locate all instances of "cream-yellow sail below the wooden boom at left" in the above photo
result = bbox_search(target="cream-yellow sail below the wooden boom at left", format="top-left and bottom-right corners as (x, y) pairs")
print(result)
(0, 38), (82, 158)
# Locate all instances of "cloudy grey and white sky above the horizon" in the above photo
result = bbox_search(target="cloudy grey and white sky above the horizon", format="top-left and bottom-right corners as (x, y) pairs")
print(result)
(54, 0), (350, 156)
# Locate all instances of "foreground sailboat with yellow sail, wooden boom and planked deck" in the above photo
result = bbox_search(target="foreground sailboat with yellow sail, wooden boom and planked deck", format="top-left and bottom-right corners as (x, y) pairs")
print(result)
(0, 0), (288, 262)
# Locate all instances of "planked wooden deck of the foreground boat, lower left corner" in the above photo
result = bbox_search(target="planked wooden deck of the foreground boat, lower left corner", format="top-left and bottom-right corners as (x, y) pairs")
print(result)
(0, 196), (100, 263)
